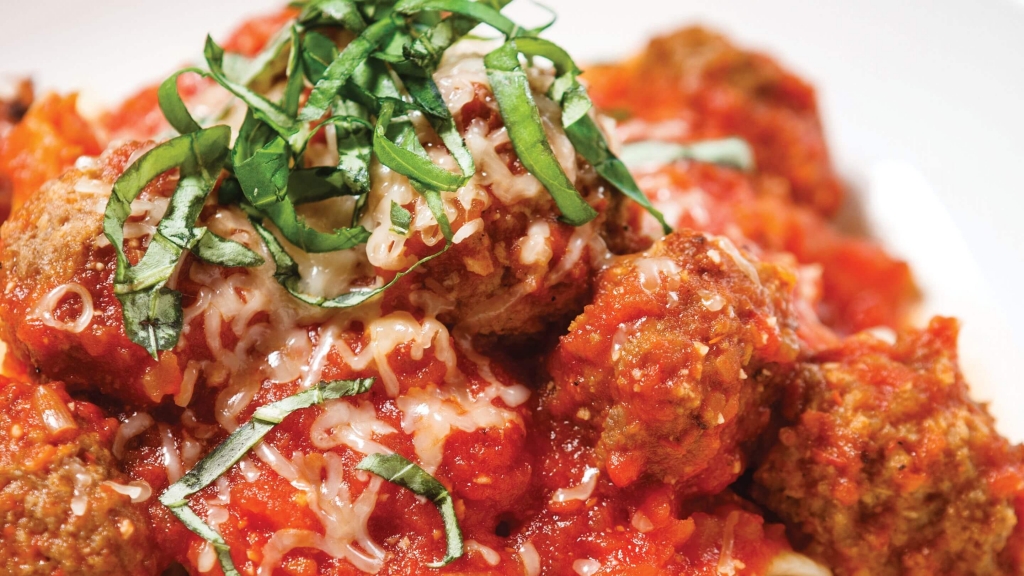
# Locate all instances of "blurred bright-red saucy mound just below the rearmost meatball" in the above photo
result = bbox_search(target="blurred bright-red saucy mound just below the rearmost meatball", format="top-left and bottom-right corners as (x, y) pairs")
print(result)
(624, 162), (918, 335)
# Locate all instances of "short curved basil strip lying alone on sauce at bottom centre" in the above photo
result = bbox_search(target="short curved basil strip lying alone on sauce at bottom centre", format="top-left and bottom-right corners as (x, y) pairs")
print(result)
(355, 454), (463, 568)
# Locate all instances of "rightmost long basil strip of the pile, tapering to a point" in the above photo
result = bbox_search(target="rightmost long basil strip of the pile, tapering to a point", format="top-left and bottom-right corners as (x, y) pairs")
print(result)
(516, 38), (672, 234)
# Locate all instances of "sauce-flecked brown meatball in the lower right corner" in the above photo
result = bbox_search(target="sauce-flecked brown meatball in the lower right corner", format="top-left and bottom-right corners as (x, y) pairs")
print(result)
(754, 318), (1024, 576)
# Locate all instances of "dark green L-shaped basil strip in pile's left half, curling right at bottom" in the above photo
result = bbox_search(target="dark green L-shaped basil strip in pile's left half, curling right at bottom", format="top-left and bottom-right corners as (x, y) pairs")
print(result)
(234, 136), (370, 252)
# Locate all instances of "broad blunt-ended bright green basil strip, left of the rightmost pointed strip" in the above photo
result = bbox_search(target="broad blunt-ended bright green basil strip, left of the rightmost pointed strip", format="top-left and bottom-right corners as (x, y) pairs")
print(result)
(483, 41), (597, 225)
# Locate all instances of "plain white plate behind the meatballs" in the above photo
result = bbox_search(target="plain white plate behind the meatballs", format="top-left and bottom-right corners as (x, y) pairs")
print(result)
(0, 0), (1024, 441)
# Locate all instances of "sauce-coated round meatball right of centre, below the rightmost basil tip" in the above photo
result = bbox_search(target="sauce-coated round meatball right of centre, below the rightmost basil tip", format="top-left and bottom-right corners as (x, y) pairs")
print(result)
(545, 228), (798, 493)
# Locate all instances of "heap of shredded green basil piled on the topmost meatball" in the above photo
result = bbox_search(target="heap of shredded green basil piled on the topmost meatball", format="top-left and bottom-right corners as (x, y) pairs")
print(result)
(104, 0), (671, 358)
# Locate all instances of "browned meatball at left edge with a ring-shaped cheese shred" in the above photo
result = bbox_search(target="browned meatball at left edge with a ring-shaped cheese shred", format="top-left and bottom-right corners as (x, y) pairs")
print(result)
(0, 143), (180, 402)
